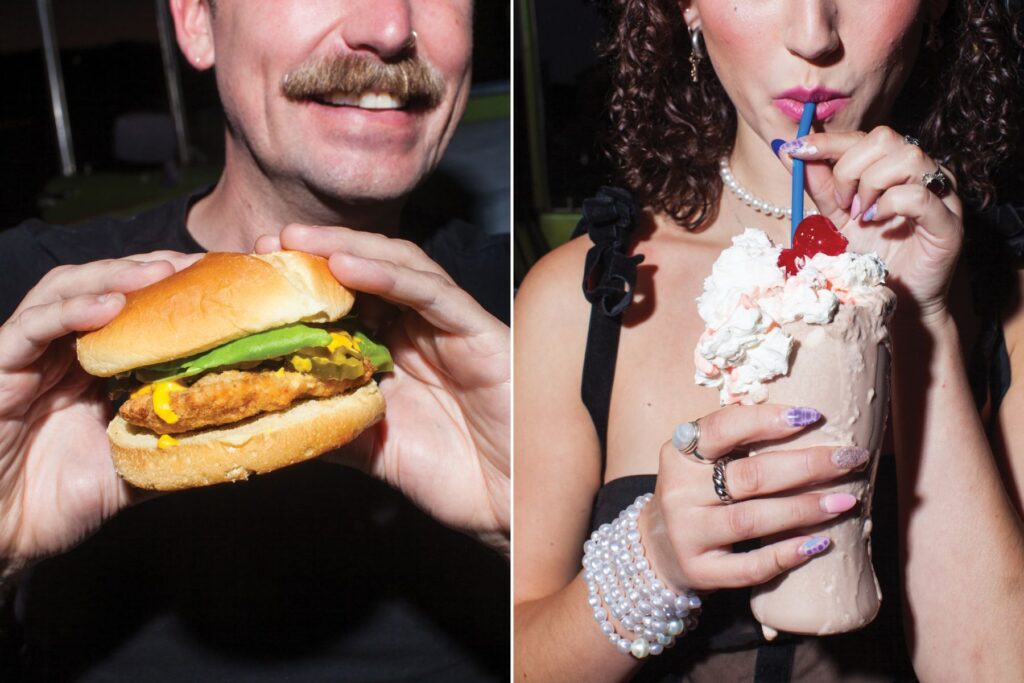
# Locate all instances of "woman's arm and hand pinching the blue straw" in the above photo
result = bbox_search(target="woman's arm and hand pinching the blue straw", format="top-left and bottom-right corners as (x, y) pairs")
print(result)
(783, 126), (1024, 681)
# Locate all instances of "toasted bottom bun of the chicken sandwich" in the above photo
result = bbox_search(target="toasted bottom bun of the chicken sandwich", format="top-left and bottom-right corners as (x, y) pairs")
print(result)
(106, 381), (384, 490)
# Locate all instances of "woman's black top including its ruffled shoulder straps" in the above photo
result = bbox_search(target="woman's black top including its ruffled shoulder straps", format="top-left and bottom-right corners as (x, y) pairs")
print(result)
(575, 187), (1024, 683)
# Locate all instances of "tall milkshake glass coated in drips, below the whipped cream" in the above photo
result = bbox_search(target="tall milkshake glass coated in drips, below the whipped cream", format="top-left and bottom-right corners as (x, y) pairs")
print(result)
(751, 287), (895, 638)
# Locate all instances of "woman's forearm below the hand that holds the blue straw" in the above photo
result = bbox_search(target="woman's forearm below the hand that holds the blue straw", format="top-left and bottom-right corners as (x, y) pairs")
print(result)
(893, 301), (1024, 681)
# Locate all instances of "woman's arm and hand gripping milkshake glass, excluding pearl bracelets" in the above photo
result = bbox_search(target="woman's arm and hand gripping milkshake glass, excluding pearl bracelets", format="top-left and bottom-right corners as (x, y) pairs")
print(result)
(514, 237), (868, 681)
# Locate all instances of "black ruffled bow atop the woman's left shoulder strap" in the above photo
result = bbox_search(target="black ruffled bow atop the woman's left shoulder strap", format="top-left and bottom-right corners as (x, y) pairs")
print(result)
(573, 187), (643, 317)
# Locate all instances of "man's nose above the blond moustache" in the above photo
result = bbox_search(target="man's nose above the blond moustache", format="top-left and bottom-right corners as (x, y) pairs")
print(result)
(342, 0), (416, 60)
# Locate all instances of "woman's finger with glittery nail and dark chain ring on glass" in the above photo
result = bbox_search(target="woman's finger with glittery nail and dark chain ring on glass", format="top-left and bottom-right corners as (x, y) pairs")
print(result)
(708, 445), (870, 506)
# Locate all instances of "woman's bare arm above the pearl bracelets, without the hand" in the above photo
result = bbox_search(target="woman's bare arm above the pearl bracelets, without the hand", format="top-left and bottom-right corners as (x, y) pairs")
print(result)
(513, 239), (636, 681)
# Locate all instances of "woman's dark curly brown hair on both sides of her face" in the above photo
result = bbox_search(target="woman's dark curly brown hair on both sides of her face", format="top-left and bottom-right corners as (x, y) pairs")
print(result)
(602, 0), (1024, 229)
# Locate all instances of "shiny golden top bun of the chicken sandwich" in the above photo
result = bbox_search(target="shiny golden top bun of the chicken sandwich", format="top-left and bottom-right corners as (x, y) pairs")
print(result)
(78, 251), (354, 377)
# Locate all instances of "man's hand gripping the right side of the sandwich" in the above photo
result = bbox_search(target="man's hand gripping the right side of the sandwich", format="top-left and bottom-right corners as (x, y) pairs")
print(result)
(256, 225), (511, 553)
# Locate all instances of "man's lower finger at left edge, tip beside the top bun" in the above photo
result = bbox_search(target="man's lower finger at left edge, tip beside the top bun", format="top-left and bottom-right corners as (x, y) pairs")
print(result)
(0, 292), (125, 372)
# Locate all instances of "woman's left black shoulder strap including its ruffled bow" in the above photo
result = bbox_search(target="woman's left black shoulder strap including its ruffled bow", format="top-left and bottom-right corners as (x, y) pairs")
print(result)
(573, 187), (643, 481)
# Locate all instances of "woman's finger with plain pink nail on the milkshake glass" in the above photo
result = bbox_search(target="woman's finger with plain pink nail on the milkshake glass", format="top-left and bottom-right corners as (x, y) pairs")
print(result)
(694, 489), (857, 549)
